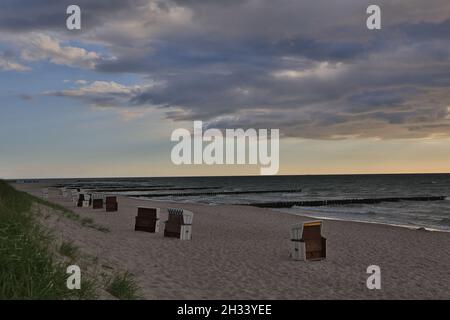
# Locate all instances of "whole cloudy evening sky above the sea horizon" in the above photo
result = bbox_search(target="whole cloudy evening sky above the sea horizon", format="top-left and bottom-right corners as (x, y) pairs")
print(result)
(0, 0), (450, 178)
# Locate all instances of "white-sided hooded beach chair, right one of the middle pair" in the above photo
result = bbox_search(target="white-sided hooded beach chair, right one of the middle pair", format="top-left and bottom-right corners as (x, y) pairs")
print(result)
(164, 208), (194, 240)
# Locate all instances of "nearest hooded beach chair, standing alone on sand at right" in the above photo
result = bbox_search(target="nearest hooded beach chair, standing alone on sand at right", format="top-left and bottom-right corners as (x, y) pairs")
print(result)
(291, 221), (327, 261)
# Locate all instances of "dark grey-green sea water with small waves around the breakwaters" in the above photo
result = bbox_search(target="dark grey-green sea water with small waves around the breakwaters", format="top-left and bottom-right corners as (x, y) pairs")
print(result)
(53, 174), (450, 231)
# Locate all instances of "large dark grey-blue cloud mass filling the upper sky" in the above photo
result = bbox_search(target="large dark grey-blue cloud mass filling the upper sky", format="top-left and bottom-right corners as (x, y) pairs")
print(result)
(0, 0), (450, 139)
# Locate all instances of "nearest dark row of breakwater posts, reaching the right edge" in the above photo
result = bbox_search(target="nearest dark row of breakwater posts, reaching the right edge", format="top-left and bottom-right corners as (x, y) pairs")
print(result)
(247, 196), (447, 208)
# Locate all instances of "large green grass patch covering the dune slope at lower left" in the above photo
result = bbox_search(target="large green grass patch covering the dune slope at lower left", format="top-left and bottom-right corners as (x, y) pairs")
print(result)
(0, 180), (95, 300)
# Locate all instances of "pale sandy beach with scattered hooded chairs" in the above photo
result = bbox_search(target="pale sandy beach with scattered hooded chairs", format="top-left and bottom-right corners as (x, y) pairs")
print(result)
(15, 184), (450, 299)
